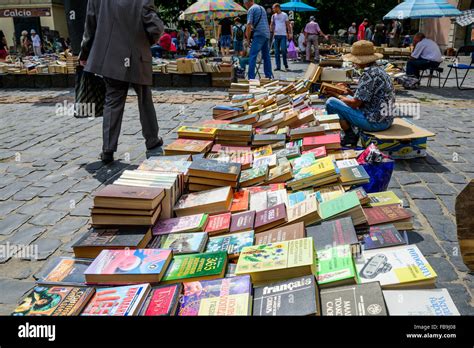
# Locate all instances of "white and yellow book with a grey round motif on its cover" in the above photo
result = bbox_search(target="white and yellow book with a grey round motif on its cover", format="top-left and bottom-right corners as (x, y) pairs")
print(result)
(356, 245), (437, 289)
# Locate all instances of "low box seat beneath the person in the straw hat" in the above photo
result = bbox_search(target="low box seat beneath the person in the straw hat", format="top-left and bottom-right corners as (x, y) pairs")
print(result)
(360, 118), (435, 159)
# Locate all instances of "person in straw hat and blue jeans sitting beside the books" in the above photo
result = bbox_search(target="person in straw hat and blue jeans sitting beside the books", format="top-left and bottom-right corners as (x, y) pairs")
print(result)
(326, 40), (395, 146)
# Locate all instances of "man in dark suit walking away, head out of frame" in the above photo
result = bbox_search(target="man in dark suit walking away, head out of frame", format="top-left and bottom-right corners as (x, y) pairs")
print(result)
(79, 0), (164, 163)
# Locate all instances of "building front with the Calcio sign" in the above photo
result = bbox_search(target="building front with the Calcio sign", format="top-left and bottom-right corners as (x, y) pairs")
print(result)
(0, 0), (68, 47)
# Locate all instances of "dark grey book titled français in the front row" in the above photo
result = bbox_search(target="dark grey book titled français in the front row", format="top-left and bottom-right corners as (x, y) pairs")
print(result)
(253, 275), (320, 316)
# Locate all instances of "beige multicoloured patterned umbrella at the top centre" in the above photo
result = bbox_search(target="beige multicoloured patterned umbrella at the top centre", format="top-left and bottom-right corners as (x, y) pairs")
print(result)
(179, 0), (247, 21)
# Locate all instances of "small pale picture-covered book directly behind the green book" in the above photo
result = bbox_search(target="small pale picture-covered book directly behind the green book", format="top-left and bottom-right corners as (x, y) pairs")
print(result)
(160, 232), (208, 255)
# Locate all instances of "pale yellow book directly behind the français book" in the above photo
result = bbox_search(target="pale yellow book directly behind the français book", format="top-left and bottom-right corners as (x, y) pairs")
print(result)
(235, 238), (314, 275)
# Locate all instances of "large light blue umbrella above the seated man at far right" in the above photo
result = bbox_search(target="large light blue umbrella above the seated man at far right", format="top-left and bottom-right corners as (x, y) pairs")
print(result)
(383, 0), (461, 19)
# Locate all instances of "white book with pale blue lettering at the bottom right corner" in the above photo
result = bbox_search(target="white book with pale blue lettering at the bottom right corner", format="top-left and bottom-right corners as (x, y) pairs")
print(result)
(383, 289), (460, 316)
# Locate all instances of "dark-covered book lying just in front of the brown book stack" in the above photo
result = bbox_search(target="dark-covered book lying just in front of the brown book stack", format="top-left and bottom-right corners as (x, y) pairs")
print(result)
(72, 226), (152, 259)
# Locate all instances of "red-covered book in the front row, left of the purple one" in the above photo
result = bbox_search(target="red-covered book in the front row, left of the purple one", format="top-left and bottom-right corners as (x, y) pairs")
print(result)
(140, 284), (183, 316)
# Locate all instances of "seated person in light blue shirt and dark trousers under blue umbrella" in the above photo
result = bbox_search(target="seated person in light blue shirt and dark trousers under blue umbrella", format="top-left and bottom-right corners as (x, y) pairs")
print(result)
(407, 33), (443, 78)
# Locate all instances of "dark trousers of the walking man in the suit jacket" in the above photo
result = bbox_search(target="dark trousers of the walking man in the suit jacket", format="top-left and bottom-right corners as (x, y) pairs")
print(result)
(102, 77), (160, 152)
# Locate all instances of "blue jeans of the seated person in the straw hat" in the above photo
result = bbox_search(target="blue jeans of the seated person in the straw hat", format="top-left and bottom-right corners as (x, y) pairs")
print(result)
(326, 97), (392, 132)
